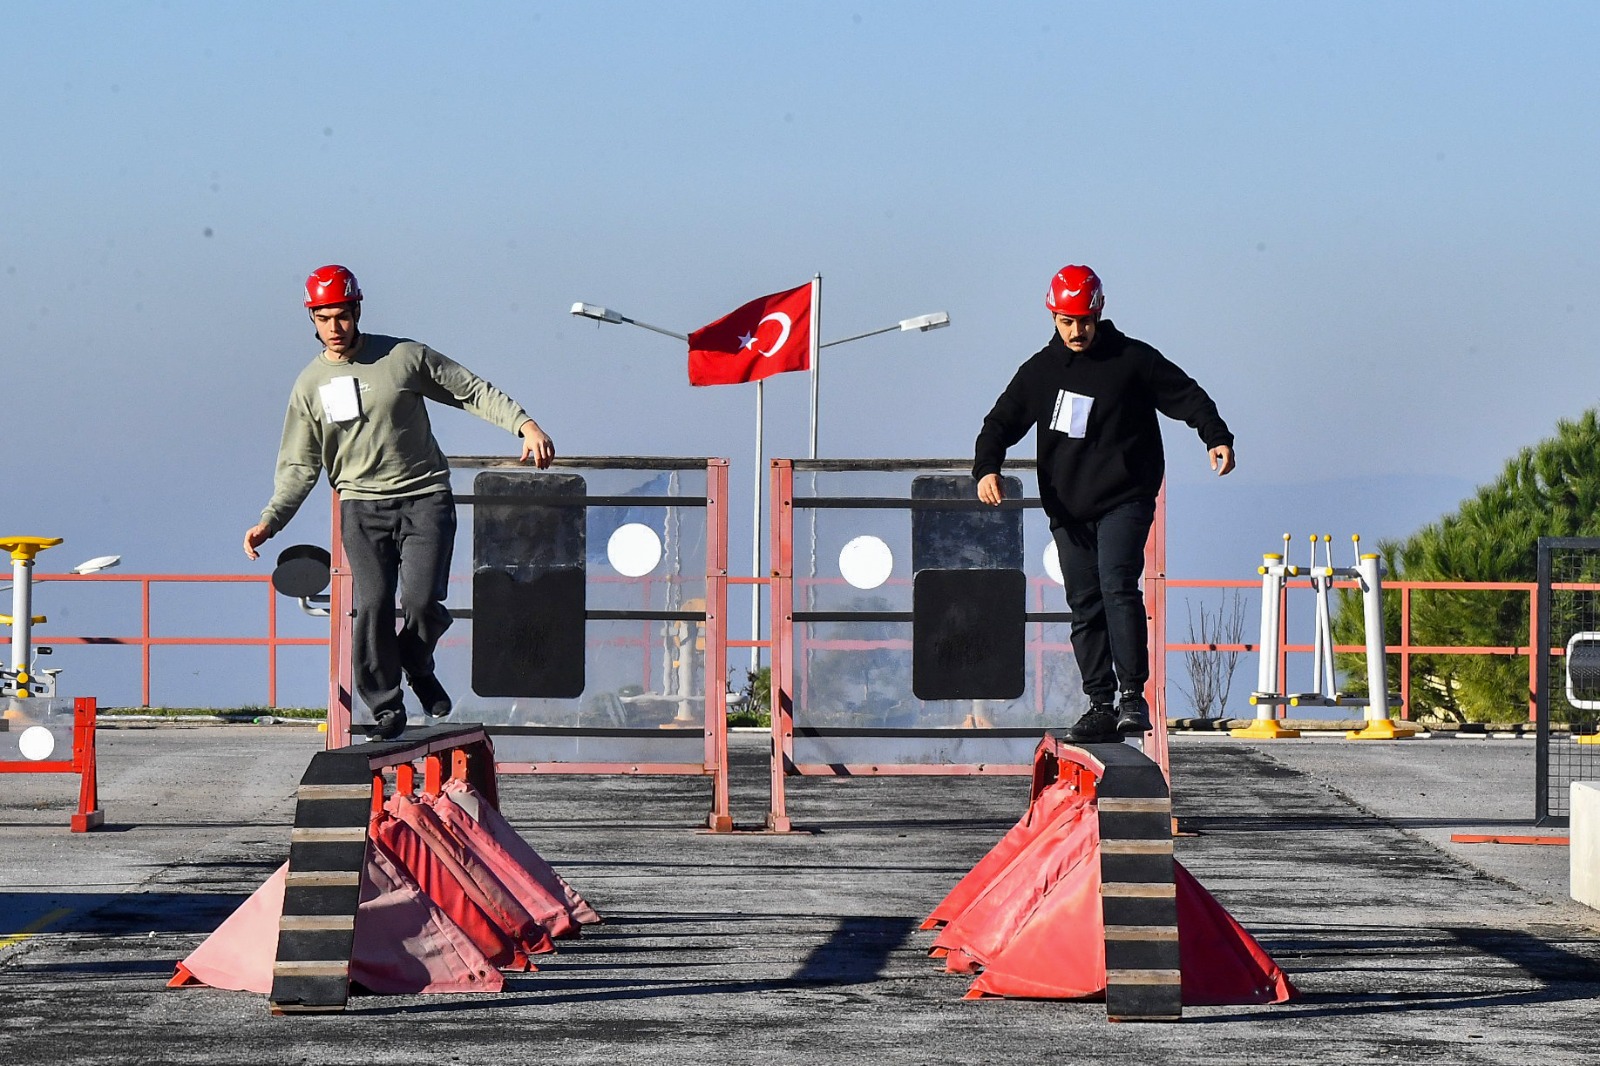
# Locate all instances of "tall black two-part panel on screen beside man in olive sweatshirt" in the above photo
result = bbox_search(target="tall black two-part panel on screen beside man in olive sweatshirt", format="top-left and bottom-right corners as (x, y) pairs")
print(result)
(472, 471), (589, 699)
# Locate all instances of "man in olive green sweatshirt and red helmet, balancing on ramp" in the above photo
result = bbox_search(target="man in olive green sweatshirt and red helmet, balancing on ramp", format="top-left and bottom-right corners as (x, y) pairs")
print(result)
(245, 266), (555, 739)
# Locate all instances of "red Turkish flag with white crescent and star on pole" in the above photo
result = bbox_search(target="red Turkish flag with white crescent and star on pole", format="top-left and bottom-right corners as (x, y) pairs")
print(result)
(690, 282), (811, 384)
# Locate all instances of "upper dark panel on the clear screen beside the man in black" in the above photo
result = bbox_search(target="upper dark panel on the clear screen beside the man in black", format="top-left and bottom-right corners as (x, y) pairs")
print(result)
(910, 474), (1022, 573)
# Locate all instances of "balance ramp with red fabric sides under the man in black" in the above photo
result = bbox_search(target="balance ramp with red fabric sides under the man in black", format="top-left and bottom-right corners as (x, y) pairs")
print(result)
(923, 736), (1296, 1021)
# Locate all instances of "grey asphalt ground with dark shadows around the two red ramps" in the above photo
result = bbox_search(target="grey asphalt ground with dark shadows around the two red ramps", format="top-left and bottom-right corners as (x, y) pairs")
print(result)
(0, 725), (1600, 1066)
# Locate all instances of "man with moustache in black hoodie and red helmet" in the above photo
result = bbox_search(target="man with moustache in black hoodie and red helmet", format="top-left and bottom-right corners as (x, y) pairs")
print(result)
(973, 266), (1234, 743)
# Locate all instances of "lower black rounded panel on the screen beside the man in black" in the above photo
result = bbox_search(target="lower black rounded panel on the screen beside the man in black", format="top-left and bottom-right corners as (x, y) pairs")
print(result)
(910, 570), (1027, 699)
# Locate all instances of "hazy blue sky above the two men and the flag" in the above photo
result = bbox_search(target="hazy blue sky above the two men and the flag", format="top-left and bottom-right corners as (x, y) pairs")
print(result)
(0, 2), (1600, 576)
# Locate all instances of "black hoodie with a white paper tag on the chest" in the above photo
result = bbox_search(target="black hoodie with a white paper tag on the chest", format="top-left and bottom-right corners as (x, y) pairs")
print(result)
(973, 320), (1234, 525)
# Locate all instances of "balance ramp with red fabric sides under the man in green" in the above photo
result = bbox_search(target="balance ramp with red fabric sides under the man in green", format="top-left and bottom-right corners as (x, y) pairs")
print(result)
(168, 727), (600, 1013)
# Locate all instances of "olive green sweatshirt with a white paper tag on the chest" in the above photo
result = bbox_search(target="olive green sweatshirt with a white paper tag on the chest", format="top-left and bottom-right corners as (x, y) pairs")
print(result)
(261, 333), (530, 533)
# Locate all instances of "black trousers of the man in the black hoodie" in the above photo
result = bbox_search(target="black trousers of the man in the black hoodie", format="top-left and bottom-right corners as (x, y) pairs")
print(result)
(1051, 499), (1155, 703)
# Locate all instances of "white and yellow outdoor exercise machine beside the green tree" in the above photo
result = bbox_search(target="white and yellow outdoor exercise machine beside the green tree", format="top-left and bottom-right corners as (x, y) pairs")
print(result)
(1232, 533), (1416, 739)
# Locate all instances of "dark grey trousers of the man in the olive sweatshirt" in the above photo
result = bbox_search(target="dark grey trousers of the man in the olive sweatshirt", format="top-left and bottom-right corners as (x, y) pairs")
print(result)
(339, 491), (456, 714)
